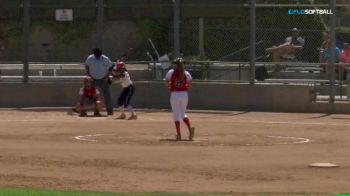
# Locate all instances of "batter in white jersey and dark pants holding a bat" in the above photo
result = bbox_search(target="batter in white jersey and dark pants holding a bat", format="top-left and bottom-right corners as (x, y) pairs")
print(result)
(114, 61), (137, 120)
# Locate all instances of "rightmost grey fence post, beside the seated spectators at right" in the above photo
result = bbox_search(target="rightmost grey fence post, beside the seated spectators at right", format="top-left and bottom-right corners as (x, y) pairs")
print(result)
(329, 0), (336, 103)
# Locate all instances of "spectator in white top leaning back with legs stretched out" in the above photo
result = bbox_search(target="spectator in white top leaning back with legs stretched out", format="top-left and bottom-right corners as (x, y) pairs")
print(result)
(266, 28), (305, 71)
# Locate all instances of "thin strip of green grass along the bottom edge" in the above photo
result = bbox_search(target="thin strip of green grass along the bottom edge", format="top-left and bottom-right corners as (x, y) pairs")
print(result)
(0, 189), (342, 196)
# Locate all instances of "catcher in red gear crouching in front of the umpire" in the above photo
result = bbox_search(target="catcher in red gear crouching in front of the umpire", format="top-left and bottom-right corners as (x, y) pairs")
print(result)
(73, 76), (102, 117)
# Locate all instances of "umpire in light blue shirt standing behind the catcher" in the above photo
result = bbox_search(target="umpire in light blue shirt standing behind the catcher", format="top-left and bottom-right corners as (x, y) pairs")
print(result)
(85, 48), (113, 115)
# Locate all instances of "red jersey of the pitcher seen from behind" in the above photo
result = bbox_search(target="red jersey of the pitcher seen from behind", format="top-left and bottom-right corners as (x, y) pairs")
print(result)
(168, 70), (192, 91)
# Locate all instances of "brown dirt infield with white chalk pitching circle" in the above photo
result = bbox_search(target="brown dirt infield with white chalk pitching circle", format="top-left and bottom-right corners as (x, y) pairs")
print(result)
(0, 109), (350, 192)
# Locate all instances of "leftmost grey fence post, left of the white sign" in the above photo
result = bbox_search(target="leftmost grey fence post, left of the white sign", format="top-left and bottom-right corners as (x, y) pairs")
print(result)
(22, 0), (30, 84)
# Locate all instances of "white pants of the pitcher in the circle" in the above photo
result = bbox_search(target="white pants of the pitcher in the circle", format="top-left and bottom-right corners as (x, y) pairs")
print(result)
(170, 91), (188, 121)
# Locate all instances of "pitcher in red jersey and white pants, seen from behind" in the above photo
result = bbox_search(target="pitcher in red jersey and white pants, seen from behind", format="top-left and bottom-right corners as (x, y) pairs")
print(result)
(166, 58), (194, 141)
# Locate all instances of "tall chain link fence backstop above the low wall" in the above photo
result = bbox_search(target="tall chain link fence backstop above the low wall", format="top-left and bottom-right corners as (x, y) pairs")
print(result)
(0, 0), (350, 86)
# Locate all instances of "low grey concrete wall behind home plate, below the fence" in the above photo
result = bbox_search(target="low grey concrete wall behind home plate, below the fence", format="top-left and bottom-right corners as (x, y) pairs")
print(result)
(0, 82), (350, 113)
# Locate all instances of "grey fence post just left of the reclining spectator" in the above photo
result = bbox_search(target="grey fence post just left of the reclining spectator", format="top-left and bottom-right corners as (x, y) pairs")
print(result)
(249, 0), (256, 84)
